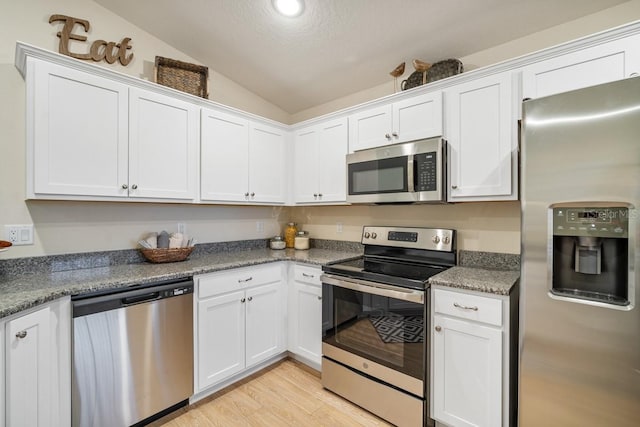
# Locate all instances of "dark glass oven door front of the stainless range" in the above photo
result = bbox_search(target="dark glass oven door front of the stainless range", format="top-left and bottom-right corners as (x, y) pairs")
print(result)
(323, 284), (426, 380)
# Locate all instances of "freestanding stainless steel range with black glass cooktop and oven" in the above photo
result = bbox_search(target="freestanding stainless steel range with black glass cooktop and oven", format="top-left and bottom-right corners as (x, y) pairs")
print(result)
(321, 226), (456, 426)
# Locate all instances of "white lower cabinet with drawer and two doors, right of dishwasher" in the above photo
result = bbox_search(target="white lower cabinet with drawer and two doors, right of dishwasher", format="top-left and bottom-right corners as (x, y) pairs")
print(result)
(195, 263), (285, 392)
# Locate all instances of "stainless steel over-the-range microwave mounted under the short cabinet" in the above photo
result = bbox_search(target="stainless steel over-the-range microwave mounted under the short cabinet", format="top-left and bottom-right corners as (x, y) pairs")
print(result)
(347, 138), (447, 203)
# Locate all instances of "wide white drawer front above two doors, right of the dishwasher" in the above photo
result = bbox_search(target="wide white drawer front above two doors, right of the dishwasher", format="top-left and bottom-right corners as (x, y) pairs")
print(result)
(197, 263), (282, 299)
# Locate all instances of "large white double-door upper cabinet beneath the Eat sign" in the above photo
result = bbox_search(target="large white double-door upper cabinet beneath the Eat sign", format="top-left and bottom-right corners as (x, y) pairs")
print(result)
(27, 59), (199, 201)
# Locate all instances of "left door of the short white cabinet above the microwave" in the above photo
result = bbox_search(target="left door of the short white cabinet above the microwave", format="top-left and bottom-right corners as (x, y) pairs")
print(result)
(349, 105), (393, 153)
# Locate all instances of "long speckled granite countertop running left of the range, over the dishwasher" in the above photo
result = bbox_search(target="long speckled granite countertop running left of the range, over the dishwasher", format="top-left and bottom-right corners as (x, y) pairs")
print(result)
(0, 248), (361, 318)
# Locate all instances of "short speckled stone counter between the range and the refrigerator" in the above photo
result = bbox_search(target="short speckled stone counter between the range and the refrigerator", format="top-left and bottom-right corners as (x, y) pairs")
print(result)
(429, 250), (520, 295)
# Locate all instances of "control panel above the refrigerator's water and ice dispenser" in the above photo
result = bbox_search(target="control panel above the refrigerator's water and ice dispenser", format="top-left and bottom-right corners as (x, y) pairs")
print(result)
(551, 206), (633, 238)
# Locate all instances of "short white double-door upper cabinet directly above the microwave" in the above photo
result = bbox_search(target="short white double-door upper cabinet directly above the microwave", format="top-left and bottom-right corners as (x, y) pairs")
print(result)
(349, 91), (442, 152)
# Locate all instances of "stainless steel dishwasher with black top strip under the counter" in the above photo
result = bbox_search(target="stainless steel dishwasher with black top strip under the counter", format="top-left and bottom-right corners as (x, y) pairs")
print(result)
(72, 280), (193, 427)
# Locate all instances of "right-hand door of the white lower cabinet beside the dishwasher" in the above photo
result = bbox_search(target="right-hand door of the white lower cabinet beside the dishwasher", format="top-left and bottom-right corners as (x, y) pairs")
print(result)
(246, 282), (284, 367)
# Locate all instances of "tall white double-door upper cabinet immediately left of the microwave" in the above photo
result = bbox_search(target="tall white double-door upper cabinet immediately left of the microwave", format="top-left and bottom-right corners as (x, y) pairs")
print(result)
(293, 118), (348, 204)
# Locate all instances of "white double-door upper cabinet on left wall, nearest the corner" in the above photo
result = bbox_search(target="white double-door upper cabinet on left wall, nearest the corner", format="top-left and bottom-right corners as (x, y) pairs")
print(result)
(200, 108), (286, 204)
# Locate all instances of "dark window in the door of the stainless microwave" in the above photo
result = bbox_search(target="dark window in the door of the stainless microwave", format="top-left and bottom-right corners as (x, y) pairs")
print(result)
(349, 157), (408, 195)
